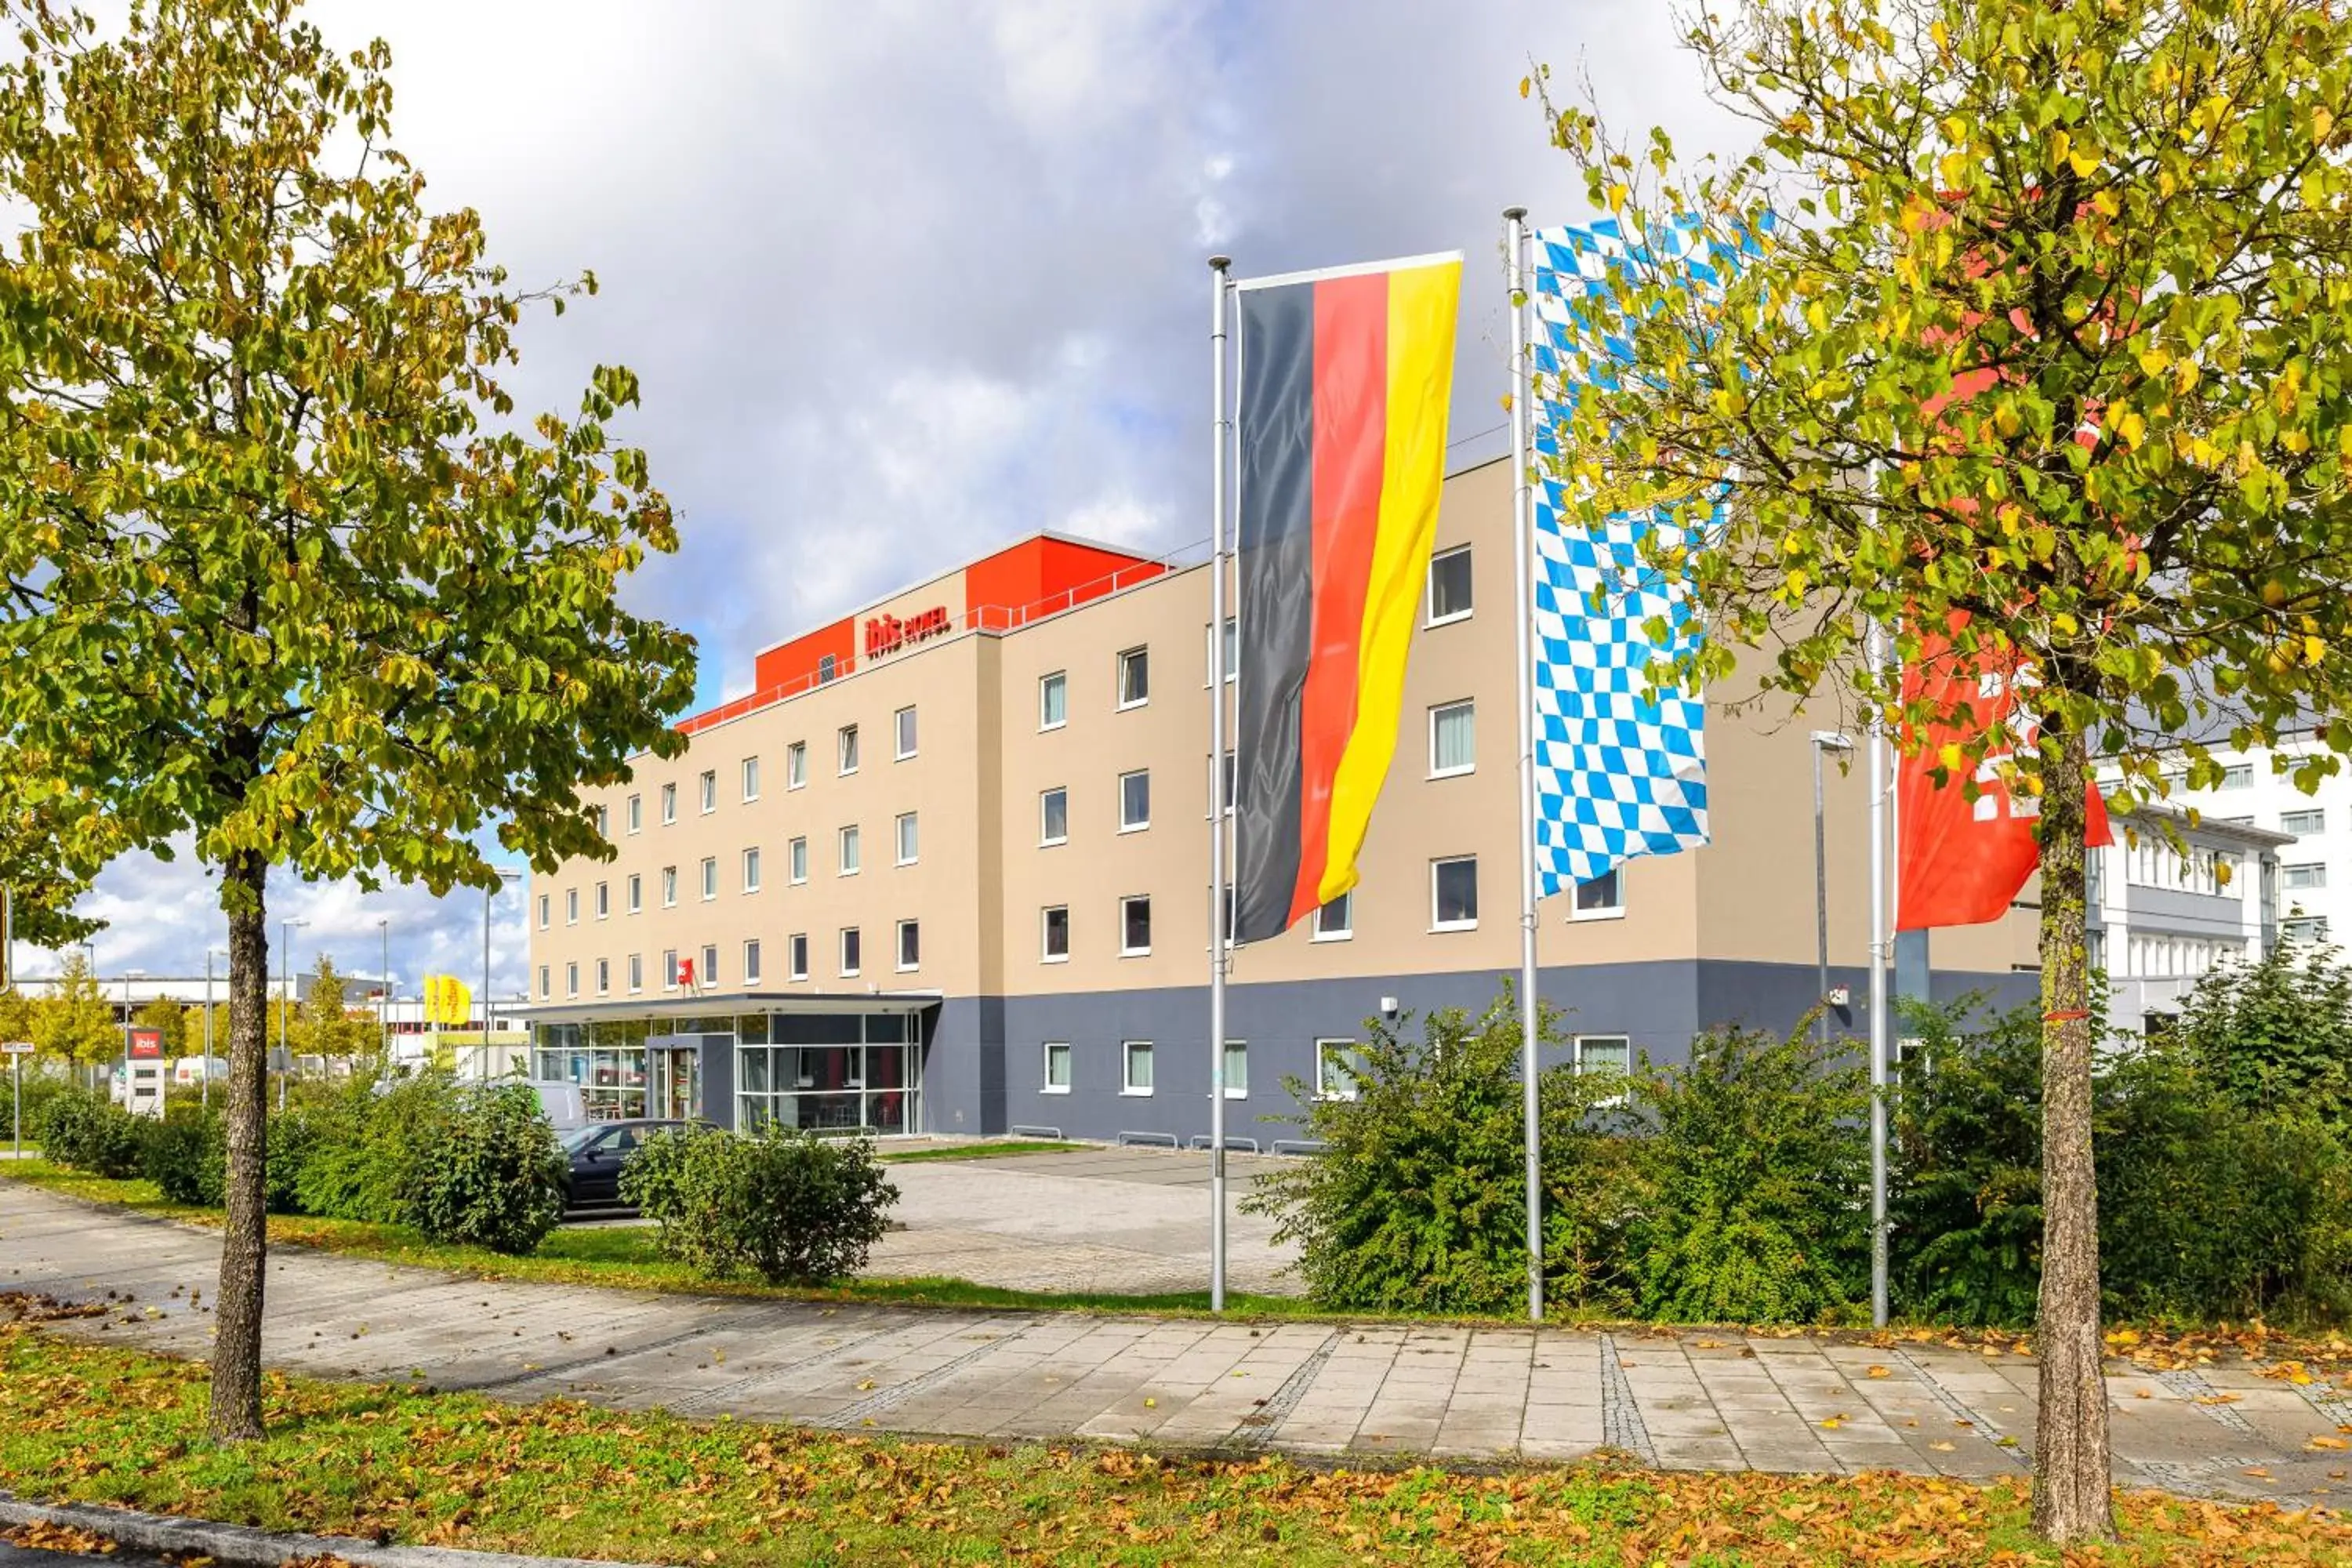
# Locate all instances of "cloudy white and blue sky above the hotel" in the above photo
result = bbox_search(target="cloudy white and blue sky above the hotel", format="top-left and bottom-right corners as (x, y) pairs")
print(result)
(19, 0), (1748, 994)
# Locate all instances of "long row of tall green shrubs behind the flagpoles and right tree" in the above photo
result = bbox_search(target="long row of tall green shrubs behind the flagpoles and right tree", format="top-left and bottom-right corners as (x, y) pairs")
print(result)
(1244, 956), (2352, 1323)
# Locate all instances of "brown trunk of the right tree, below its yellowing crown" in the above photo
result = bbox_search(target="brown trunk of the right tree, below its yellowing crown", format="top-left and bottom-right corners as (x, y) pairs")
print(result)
(2034, 731), (2114, 1542)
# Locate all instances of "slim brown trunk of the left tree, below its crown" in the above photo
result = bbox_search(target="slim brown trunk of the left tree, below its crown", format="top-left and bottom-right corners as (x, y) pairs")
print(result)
(212, 851), (270, 1443)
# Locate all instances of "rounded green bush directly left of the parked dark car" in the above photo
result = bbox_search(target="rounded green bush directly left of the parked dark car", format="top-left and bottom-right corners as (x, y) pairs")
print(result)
(412, 1083), (564, 1255)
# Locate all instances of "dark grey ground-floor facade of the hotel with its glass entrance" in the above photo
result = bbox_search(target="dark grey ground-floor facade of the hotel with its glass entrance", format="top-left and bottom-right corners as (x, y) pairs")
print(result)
(534, 959), (2037, 1147)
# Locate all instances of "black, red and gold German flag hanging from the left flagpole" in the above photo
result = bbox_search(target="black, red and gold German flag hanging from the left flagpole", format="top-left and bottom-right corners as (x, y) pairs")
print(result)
(1232, 252), (1463, 942)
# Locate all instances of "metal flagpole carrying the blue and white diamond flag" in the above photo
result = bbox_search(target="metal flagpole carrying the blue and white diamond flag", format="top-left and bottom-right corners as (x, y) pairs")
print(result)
(1503, 207), (1543, 1323)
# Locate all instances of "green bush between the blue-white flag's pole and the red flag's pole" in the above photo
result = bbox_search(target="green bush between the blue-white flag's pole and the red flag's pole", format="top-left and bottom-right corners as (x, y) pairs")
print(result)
(1628, 1022), (1870, 1323)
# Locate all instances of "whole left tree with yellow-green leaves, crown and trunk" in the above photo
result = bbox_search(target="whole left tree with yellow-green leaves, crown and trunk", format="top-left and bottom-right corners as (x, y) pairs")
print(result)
(0, 0), (694, 1441)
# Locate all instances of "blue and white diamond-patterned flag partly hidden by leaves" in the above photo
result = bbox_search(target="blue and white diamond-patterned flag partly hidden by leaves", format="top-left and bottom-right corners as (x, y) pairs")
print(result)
(1531, 219), (1738, 898)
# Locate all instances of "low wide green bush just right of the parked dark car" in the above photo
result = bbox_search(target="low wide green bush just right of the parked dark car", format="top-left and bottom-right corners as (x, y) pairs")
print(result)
(635, 1123), (898, 1283)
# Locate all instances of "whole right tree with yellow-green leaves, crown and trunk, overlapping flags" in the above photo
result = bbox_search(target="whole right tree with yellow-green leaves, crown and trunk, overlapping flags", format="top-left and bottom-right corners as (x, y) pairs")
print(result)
(1552, 0), (2352, 1540)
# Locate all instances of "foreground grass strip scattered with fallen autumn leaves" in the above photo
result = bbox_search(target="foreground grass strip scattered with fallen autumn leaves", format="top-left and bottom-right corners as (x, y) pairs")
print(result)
(0, 1323), (2352, 1568)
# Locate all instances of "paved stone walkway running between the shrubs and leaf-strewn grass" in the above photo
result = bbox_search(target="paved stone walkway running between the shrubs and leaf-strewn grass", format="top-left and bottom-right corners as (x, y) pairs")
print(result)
(0, 1185), (2352, 1500)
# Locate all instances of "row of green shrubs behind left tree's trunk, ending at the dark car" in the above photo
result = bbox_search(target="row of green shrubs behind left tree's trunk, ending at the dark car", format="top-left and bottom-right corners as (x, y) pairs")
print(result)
(35, 1074), (564, 1253)
